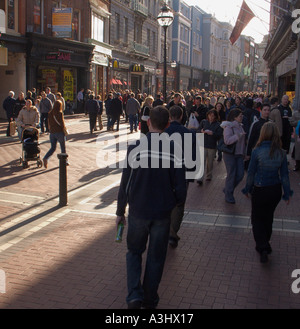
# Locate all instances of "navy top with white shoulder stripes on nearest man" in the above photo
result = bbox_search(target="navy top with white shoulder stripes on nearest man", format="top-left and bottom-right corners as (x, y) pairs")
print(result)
(116, 133), (187, 220)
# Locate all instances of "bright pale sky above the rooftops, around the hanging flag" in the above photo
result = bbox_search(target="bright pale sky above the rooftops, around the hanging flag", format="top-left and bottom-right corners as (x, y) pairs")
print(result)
(188, 0), (270, 43)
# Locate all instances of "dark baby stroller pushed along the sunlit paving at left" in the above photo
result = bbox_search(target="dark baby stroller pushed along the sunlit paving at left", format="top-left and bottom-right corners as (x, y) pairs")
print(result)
(20, 127), (43, 169)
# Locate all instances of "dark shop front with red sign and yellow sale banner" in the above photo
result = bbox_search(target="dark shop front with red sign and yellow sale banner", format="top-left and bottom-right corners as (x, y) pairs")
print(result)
(27, 34), (94, 102)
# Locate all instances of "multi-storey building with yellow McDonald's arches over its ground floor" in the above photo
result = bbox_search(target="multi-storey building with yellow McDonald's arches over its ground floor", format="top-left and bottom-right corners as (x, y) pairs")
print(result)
(110, 0), (159, 93)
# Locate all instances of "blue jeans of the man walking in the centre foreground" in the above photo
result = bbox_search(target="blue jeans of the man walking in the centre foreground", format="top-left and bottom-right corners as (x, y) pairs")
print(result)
(126, 215), (170, 308)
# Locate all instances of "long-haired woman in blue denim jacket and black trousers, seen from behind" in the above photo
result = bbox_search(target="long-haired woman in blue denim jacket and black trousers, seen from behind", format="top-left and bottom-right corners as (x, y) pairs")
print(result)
(242, 122), (293, 263)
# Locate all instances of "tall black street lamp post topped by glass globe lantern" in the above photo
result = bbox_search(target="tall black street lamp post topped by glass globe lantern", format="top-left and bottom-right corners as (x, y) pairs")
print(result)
(157, 3), (174, 102)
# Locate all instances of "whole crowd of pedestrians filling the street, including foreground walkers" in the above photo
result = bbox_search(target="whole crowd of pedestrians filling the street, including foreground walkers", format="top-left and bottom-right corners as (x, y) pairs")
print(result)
(3, 87), (300, 308)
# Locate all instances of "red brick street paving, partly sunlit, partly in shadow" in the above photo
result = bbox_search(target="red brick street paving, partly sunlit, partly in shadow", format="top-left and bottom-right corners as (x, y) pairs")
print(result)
(0, 116), (300, 309)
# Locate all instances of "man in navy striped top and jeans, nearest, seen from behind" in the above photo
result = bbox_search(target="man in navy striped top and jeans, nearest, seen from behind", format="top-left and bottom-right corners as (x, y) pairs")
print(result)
(116, 106), (187, 309)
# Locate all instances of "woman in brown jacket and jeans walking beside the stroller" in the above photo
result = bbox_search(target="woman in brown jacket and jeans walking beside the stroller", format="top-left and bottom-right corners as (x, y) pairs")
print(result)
(43, 100), (68, 169)
